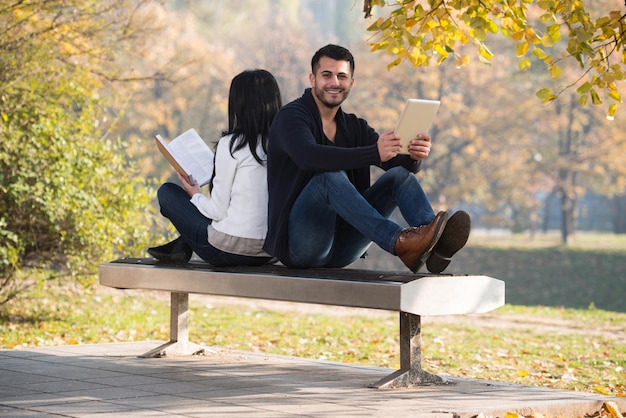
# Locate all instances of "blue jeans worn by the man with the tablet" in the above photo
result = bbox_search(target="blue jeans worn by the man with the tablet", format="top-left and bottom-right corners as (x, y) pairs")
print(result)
(281, 167), (435, 268)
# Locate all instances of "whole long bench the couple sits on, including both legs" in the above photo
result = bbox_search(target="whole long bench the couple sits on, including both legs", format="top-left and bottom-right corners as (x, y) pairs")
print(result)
(99, 258), (504, 388)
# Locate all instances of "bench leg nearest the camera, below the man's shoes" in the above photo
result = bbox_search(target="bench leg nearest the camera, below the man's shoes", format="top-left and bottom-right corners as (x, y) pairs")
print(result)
(370, 312), (446, 389)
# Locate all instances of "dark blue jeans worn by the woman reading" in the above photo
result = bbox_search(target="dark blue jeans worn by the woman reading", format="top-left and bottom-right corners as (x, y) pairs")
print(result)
(157, 183), (270, 267)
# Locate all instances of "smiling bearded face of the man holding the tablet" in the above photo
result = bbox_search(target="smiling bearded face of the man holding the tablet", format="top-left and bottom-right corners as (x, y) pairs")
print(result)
(309, 57), (354, 108)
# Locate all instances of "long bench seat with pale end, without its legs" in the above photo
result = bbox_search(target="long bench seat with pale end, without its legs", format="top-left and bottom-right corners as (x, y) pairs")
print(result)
(99, 259), (504, 315)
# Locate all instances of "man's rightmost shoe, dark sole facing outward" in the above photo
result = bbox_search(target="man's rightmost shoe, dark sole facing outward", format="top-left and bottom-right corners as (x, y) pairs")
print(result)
(426, 210), (472, 274)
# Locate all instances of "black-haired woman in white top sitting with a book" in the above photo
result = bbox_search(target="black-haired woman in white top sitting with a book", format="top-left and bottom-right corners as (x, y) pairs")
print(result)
(148, 69), (282, 266)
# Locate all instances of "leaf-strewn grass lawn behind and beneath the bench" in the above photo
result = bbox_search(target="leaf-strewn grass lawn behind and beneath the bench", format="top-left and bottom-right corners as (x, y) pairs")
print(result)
(0, 232), (626, 396)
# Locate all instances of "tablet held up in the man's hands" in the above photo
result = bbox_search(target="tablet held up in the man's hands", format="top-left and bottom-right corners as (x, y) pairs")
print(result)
(394, 99), (441, 154)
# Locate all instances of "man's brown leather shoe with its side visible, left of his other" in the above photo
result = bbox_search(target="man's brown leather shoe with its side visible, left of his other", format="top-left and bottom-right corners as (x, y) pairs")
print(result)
(394, 211), (448, 273)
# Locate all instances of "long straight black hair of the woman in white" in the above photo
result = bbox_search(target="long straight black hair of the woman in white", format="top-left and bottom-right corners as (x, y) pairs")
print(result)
(222, 69), (282, 165)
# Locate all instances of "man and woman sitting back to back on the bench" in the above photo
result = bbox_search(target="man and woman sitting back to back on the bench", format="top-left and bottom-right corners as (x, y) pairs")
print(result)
(148, 45), (470, 274)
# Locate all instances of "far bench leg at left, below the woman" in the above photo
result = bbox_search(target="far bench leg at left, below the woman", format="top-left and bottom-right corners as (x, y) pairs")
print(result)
(139, 292), (206, 358)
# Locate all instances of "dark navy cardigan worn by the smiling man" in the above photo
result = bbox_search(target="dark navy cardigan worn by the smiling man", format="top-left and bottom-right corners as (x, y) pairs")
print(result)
(263, 88), (420, 260)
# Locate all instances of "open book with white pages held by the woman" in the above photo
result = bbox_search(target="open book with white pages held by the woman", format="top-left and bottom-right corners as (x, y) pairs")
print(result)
(154, 128), (214, 186)
